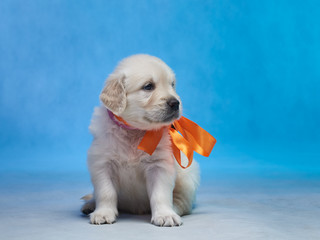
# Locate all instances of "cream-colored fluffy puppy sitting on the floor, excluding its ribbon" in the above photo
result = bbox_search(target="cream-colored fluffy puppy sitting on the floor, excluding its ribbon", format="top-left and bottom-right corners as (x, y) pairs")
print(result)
(82, 55), (199, 226)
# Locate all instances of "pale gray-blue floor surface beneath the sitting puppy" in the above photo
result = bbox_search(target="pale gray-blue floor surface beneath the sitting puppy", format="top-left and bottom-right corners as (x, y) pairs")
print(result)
(0, 173), (320, 240)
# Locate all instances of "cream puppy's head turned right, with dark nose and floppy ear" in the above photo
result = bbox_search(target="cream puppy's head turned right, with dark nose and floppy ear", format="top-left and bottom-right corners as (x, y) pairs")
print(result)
(100, 54), (182, 130)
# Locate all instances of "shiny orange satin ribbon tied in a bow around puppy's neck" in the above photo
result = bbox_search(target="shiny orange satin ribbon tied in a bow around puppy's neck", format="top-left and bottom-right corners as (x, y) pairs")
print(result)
(115, 116), (216, 168)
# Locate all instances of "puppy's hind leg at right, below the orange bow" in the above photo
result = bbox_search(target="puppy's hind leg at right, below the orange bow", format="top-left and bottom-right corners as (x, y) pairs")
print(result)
(173, 161), (200, 216)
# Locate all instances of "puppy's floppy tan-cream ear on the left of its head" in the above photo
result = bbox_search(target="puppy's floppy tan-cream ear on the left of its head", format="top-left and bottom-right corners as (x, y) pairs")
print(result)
(100, 74), (127, 115)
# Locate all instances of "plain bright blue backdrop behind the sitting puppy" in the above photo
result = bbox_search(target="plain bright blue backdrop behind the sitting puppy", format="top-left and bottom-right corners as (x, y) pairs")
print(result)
(0, 0), (320, 174)
